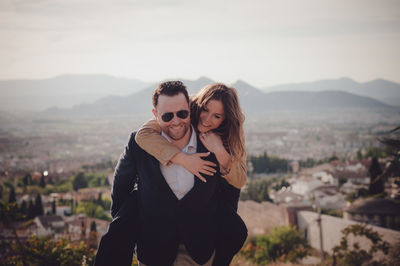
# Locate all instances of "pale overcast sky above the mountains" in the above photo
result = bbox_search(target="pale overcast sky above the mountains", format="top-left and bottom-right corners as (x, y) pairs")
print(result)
(0, 0), (400, 88)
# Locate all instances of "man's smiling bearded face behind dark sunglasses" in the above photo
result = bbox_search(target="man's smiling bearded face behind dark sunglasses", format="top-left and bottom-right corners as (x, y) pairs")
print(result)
(153, 93), (190, 140)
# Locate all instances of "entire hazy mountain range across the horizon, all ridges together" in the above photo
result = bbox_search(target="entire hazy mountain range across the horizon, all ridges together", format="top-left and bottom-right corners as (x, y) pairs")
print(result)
(0, 75), (400, 116)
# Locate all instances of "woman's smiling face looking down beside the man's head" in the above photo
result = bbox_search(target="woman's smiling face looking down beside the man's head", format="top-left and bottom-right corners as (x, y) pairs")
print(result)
(197, 100), (225, 133)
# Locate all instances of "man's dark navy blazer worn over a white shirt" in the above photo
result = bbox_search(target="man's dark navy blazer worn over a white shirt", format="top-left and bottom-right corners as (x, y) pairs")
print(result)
(111, 133), (221, 266)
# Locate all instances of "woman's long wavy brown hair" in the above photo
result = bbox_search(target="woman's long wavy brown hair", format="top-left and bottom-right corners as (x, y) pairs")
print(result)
(190, 83), (245, 160)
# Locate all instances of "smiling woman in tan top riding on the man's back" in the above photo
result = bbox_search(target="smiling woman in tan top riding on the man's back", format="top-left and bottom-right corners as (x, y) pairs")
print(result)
(136, 83), (247, 265)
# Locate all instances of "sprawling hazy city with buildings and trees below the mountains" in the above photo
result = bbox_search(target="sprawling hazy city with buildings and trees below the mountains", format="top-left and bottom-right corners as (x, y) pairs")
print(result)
(0, 83), (400, 265)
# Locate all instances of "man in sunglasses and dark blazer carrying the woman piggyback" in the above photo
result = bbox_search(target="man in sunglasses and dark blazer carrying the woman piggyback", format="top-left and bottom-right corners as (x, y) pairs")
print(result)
(96, 81), (220, 266)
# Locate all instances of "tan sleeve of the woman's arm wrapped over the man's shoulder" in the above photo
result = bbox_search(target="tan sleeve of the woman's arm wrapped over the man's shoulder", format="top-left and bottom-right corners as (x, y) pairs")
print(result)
(135, 118), (180, 165)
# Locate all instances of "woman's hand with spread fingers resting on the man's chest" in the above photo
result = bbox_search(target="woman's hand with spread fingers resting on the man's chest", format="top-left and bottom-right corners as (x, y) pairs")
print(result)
(171, 152), (217, 182)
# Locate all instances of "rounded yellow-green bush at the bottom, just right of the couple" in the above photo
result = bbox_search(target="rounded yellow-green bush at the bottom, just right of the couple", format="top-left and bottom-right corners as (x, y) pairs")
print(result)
(241, 226), (310, 265)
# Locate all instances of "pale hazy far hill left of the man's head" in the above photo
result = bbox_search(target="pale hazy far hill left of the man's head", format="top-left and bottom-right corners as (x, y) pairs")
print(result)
(0, 75), (150, 110)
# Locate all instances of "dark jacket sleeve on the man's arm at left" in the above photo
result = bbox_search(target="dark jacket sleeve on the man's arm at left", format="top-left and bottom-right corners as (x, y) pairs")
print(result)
(111, 133), (137, 218)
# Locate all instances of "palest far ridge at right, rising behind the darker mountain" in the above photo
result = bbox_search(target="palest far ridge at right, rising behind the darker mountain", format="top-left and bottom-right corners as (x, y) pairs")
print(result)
(263, 78), (400, 106)
